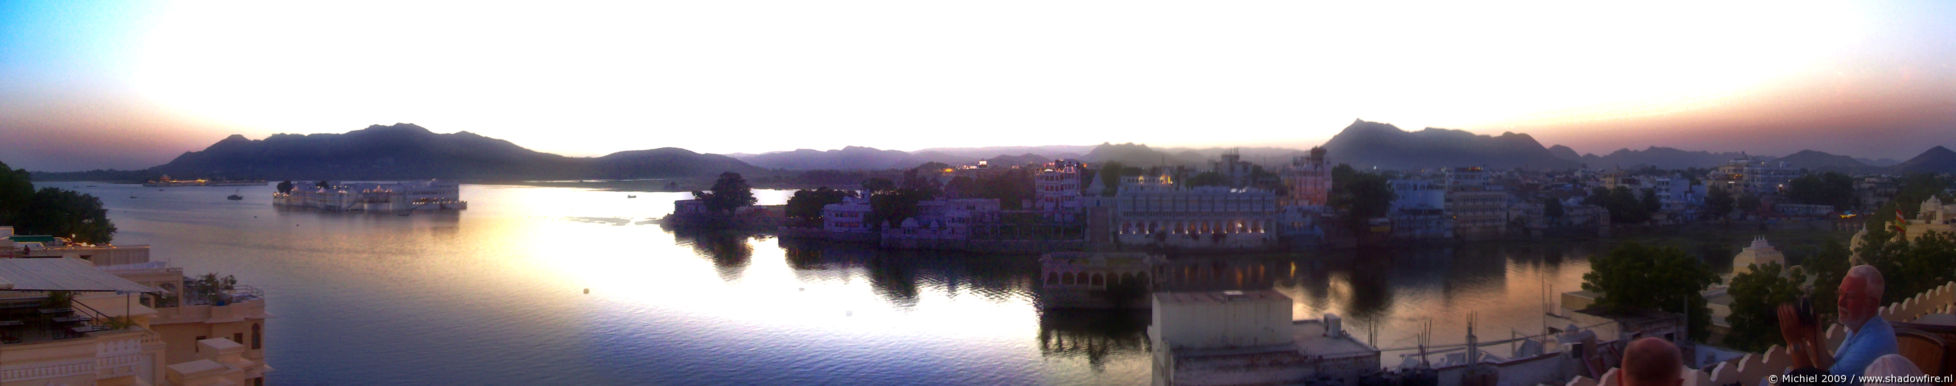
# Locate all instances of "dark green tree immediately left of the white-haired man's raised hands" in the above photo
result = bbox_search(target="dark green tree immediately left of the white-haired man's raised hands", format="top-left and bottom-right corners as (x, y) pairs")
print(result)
(1725, 263), (1799, 353)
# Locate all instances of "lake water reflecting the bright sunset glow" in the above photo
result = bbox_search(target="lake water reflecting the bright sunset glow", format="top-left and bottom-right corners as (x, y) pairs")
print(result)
(41, 182), (1643, 384)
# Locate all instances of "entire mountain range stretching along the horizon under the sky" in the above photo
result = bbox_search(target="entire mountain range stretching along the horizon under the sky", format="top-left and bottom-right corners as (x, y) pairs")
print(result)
(33, 120), (1956, 180)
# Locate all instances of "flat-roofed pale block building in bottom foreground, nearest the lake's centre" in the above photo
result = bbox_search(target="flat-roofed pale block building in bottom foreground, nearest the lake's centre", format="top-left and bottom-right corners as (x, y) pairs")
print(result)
(1148, 290), (1381, 384)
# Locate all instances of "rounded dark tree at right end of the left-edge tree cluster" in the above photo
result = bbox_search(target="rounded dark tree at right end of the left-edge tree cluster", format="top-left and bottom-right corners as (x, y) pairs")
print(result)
(20, 188), (115, 243)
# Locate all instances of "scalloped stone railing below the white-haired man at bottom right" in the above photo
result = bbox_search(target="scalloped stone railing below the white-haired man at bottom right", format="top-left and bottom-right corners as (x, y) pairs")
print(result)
(1567, 282), (1956, 386)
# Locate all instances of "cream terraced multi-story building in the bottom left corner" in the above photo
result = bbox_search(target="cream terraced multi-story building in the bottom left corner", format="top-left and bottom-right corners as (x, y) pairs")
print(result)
(0, 227), (272, 384)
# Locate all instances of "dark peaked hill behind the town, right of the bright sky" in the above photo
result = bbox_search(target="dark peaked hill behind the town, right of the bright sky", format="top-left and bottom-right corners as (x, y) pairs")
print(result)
(1324, 120), (1578, 170)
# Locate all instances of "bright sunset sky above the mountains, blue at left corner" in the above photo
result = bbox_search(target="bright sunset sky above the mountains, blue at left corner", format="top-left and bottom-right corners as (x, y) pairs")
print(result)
(0, 0), (1956, 170)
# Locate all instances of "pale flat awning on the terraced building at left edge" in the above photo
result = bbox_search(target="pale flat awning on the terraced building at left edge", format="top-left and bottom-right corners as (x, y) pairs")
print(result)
(0, 257), (162, 294)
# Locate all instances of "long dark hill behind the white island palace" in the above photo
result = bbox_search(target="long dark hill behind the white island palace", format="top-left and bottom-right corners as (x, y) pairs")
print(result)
(35, 123), (761, 180)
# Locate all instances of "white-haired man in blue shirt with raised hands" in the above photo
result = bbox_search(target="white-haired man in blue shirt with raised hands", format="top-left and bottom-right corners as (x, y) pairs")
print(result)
(1780, 265), (1901, 384)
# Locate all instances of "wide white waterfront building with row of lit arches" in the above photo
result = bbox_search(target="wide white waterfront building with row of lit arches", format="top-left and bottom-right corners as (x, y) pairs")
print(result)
(1115, 185), (1277, 249)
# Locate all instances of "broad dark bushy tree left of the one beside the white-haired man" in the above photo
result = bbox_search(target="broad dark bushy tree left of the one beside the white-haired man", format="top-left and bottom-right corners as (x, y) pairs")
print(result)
(1582, 243), (1719, 339)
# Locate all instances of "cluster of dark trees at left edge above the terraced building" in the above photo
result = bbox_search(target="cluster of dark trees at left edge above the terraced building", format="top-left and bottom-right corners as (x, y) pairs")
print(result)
(0, 163), (115, 243)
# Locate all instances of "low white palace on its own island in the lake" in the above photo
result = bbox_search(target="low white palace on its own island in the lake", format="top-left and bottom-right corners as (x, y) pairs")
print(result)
(272, 180), (469, 214)
